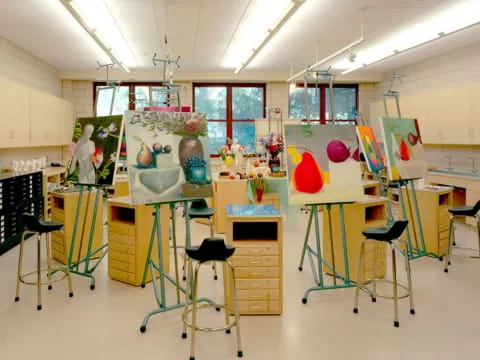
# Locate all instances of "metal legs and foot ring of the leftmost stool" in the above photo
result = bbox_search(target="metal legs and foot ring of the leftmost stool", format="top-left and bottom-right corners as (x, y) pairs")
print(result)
(15, 230), (73, 310)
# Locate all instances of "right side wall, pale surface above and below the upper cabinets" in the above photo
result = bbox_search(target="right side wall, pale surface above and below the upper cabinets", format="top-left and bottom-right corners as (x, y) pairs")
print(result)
(373, 42), (480, 170)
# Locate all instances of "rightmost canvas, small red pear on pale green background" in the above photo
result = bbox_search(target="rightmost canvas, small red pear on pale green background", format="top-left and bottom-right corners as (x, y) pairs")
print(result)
(380, 117), (425, 180)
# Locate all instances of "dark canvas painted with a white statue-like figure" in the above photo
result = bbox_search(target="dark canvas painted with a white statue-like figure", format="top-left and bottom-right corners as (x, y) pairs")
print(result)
(67, 115), (122, 185)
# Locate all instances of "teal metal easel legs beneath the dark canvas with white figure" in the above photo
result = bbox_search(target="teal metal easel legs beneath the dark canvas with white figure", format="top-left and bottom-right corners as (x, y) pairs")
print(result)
(67, 184), (108, 290)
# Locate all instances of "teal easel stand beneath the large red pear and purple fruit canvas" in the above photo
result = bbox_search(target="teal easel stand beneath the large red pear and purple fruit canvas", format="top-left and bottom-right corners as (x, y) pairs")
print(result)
(298, 201), (355, 304)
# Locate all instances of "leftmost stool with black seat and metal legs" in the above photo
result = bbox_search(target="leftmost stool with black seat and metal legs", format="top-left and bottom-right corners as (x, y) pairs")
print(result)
(15, 214), (73, 310)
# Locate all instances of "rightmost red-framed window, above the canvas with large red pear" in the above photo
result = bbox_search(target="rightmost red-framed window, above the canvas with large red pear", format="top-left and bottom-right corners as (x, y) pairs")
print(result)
(289, 84), (358, 124)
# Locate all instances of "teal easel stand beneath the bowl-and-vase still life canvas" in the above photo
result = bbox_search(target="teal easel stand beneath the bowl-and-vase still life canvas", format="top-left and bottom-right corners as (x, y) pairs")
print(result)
(140, 197), (213, 333)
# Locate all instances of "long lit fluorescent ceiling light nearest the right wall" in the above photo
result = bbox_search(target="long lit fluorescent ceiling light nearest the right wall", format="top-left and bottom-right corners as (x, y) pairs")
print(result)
(333, 0), (480, 75)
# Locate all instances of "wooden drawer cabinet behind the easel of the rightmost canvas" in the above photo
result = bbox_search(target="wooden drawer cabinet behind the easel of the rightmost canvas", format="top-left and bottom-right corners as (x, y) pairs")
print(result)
(389, 186), (452, 256)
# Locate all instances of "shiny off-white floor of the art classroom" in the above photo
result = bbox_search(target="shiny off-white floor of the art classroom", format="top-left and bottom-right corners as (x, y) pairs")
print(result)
(0, 208), (480, 360)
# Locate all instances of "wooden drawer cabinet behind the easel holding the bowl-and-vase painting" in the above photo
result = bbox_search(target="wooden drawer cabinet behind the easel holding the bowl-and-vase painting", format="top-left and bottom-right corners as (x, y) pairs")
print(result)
(107, 197), (170, 286)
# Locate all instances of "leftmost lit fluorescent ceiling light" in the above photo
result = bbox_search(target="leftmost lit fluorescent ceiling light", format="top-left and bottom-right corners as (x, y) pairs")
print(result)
(60, 0), (137, 72)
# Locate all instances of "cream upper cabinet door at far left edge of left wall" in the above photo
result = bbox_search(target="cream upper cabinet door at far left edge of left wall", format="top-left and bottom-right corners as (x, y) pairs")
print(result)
(0, 78), (30, 148)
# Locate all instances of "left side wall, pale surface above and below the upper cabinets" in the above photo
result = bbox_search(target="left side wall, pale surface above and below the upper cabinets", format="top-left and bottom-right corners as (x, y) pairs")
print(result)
(0, 37), (66, 169)
